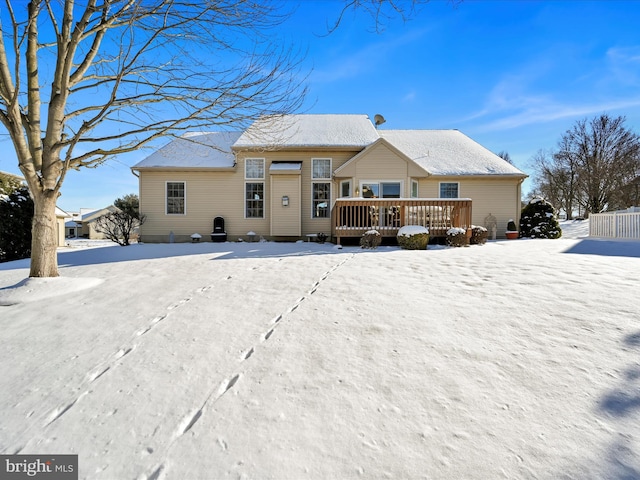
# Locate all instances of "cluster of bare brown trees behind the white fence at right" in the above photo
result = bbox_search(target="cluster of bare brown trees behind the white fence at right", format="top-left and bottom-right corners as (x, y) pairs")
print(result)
(533, 114), (640, 219)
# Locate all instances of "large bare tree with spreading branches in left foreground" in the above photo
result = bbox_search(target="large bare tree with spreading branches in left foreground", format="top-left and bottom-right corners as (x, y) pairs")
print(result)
(0, 0), (305, 277)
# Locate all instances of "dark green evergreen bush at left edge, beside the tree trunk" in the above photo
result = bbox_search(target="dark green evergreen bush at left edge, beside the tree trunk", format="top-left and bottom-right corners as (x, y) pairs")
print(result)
(0, 187), (33, 262)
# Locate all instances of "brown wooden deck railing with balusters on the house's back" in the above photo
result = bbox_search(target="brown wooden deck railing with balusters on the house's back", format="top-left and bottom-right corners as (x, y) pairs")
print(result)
(332, 198), (471, 244)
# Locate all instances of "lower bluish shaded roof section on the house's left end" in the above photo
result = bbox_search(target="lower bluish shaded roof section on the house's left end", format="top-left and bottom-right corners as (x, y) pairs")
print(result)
(131, 132), (241, 170)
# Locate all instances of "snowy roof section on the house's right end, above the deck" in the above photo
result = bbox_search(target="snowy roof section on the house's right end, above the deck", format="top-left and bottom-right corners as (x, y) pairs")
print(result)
(379, 130), (527, 177)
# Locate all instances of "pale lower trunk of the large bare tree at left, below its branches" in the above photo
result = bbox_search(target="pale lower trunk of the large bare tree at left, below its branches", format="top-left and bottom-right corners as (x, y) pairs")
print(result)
(29, 191), (58, 277)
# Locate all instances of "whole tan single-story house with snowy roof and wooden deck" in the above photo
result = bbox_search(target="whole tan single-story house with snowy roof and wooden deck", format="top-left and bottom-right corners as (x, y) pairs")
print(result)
(132, 115), (527, 242)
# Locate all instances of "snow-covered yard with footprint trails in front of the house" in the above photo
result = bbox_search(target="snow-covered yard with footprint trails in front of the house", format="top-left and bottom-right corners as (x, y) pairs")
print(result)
(0, 222), (640, 480)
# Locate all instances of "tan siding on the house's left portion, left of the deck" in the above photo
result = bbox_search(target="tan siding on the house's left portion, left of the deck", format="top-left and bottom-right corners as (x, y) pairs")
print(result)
(139, 150), (358, 242)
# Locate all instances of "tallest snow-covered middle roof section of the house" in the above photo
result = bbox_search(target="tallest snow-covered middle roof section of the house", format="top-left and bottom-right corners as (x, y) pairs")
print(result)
(234, 114), (378, 149)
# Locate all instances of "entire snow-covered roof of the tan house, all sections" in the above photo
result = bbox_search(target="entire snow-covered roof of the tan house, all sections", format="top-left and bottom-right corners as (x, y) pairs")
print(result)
(131, 114), (527, 178)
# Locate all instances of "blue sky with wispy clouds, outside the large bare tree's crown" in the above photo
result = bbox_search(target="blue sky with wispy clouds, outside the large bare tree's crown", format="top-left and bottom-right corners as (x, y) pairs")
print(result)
(0, 0), (640, 211)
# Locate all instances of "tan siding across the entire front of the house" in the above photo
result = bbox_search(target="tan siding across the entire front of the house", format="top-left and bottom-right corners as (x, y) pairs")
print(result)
(139, 146), (520, 242)
